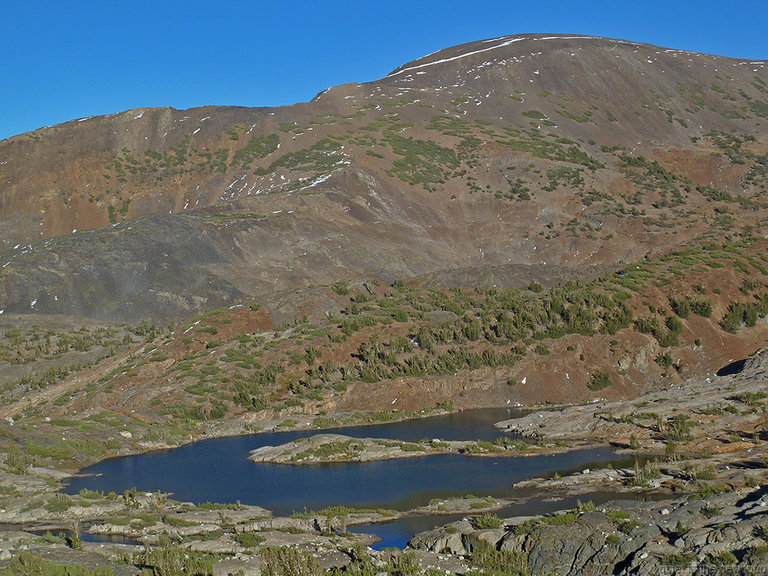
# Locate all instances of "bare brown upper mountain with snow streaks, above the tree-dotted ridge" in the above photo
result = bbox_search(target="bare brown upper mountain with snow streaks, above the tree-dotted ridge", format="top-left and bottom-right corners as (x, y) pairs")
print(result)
(0, 35), (768, 320)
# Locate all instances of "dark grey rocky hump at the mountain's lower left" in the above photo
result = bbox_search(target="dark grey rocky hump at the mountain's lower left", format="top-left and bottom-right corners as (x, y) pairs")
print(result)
(2, 215), (242, 320)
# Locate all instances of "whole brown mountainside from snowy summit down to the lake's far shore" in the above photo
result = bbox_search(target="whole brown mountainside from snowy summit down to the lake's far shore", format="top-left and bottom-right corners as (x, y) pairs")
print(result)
(0, 35), (768, 432)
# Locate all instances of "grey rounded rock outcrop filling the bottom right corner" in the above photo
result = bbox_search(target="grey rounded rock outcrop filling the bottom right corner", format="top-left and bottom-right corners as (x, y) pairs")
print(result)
(409, 488), (768, 576)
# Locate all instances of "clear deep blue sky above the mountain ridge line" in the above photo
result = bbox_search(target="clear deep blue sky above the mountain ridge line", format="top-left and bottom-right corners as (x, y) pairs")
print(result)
(0, 0), (768, 139)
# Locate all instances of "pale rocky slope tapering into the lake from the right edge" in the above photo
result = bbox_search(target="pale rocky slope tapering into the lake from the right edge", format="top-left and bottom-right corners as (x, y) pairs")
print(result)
(496, 351), (768, 459)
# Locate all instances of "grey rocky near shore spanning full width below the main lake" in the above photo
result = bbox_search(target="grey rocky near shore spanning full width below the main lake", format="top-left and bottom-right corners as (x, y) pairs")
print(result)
(0, 458), (768, 576)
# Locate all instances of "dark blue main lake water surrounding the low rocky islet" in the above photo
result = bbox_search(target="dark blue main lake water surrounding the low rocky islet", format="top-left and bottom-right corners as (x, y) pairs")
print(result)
(66, 410), (622, 515)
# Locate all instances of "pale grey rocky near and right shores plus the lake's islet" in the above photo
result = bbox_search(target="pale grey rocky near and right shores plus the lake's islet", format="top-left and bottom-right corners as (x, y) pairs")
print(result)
(0, 353), (768, 576)
